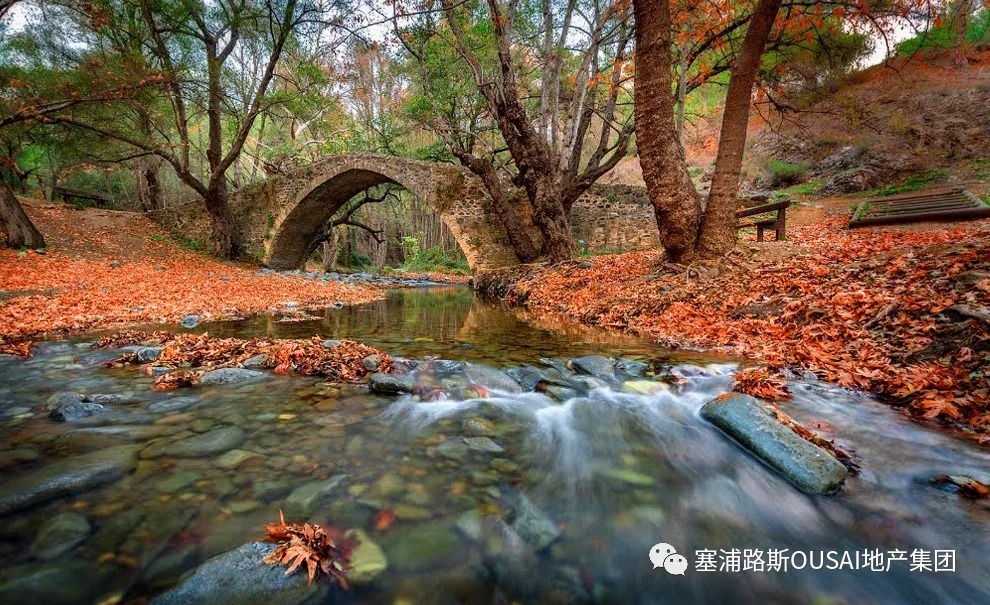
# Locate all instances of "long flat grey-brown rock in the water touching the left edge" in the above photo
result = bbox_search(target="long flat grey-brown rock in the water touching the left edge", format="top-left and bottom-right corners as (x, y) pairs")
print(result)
(0, 446), (137, 514)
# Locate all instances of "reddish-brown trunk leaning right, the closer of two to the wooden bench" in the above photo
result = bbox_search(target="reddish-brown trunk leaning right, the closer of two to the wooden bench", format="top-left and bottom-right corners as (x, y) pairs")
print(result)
(698, 0), (781, 257)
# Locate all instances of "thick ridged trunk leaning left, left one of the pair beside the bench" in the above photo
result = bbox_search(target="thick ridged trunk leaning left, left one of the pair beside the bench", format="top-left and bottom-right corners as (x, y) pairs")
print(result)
(633, 0), (701, 262)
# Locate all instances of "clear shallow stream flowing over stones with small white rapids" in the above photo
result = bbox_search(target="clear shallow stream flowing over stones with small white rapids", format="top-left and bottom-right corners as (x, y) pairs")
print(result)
(0, 288), (990, 605)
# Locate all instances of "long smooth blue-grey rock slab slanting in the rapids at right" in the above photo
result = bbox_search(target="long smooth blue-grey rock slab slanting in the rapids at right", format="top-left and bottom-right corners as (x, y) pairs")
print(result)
(701, 394), (848, 494)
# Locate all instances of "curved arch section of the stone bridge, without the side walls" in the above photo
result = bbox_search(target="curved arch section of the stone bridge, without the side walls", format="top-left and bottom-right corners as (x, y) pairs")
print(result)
(263, 154), (518, 271)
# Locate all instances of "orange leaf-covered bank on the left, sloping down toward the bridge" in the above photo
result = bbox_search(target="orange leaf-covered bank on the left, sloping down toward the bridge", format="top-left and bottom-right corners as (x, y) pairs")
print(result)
(0, 202), (381, 341)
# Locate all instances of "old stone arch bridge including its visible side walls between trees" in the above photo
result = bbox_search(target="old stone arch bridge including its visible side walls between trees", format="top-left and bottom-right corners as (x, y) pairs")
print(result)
(158, 154), (659, 272)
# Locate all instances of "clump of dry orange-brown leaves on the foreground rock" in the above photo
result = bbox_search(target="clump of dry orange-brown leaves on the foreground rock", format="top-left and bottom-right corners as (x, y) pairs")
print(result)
(264, 511), (357, 588)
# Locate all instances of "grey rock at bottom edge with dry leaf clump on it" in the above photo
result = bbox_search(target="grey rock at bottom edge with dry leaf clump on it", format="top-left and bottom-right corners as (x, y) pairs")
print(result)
(151, 542), (330, 605)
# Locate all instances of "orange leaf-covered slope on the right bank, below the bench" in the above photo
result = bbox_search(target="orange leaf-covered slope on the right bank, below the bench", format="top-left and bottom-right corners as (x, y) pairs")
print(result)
(486, 216), (990, 442)
